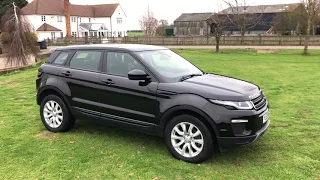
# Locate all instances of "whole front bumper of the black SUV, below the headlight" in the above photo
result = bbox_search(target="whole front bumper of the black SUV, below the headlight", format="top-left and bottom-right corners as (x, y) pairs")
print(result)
(203, 100), (270, 151)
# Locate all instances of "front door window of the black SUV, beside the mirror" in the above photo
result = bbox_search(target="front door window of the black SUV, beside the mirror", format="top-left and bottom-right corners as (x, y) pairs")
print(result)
(104, 52), (145, 77)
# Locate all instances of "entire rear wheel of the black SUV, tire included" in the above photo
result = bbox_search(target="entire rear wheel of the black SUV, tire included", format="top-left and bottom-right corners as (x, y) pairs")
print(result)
(40, 95), (75, 133)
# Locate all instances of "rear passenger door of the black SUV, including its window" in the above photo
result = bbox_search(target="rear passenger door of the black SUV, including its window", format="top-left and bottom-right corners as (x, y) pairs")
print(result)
(59, 50), (103, 118)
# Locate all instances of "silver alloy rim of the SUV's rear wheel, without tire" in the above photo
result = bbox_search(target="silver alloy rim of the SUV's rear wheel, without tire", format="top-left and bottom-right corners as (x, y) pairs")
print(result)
(43, 101), (63, 128)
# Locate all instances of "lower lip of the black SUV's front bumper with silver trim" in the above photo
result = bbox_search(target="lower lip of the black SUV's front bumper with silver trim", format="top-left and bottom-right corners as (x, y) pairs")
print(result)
(217, 120), (270, 149)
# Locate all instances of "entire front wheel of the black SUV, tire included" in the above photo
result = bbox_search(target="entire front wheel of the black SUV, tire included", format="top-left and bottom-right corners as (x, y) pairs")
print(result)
(164, 115), (213, 163)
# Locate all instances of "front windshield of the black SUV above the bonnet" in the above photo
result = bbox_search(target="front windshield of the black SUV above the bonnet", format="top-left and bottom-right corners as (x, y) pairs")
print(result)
(137, 50), (203, 82)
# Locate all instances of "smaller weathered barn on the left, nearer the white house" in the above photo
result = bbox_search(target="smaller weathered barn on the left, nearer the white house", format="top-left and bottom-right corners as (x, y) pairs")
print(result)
(174, 13), (212, 36)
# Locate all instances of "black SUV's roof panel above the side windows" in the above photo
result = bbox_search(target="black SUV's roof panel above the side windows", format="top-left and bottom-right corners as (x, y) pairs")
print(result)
(55, 44), (168, 52)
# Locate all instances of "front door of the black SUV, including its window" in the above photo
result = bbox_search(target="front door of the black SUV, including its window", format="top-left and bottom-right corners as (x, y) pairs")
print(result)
(100, 52), (159, 127)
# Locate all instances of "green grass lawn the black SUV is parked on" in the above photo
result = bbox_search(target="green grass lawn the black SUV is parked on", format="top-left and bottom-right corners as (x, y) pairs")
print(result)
(0, 50), (320, 179)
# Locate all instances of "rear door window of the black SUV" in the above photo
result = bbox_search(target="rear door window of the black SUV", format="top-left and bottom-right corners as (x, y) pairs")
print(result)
(70, 51), (102, 71)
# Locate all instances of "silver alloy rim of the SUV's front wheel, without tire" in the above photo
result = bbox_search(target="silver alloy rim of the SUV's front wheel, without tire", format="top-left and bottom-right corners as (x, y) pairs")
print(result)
(171, 122), (204, 158)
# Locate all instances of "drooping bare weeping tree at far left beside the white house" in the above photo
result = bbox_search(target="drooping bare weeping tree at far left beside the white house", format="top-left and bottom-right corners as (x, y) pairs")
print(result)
(2, 2), (38, 66)
